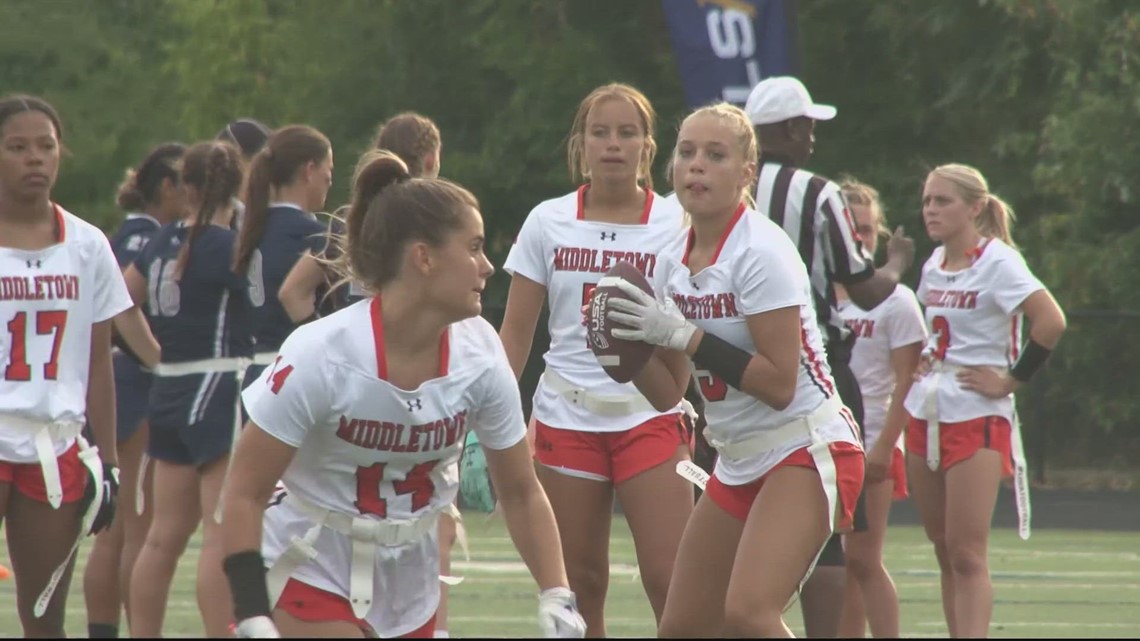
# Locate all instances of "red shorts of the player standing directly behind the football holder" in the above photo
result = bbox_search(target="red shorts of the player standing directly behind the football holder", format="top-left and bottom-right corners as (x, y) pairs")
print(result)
(535, 414), (689, 484)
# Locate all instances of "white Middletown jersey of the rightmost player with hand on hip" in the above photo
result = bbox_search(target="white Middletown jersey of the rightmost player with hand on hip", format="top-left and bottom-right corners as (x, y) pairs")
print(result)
(906, 238), (1044, 423)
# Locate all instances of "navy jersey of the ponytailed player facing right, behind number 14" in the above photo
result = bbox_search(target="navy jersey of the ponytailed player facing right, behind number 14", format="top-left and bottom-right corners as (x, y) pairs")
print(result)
(249, 205), (327, 352)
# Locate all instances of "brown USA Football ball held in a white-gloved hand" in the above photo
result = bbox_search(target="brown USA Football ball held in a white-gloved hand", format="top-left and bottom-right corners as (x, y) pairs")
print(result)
(586, 260), (654, 383)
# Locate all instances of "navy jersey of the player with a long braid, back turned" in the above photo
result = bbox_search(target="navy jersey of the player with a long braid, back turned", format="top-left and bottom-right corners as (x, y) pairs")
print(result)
(135, 222), (253, 427)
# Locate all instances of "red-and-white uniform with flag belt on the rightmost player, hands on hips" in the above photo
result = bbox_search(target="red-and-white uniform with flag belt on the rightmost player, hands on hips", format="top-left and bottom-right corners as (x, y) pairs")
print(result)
(906, 238), (1044, 538)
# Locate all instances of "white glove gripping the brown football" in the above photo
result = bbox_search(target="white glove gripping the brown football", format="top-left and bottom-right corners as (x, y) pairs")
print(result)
(605, 278), (697, 351)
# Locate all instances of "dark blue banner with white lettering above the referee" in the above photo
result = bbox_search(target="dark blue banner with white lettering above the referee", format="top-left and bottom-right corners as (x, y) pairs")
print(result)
(661, 0), (796, 108)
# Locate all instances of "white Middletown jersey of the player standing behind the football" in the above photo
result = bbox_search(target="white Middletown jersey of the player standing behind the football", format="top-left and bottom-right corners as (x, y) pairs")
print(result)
(503, 186), (682, 432)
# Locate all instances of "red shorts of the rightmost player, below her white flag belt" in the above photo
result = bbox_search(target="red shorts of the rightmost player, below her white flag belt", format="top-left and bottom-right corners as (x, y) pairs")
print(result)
(906, 416), (1013, 477)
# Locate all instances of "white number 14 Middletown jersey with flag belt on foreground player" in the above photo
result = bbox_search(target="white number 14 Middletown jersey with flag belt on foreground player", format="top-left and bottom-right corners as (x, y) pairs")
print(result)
(243, 298), (526, 636)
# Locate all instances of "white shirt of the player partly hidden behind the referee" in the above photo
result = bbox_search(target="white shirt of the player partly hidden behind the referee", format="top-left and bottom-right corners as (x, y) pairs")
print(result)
(839, 285), (927, 451)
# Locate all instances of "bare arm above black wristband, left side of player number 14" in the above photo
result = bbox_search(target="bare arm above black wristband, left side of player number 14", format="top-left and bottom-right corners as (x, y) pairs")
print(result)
(221, 421), (296, 554)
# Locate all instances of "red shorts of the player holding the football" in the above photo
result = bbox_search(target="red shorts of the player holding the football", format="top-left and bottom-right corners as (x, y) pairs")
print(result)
(705, 441), (866, 532)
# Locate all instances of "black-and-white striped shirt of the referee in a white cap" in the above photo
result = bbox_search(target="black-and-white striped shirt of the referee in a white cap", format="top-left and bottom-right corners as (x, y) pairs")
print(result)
(756, 155), (874, 347)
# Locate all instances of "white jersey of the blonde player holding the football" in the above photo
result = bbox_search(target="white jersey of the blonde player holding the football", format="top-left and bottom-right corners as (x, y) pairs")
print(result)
(651, 205), (860, 485)
